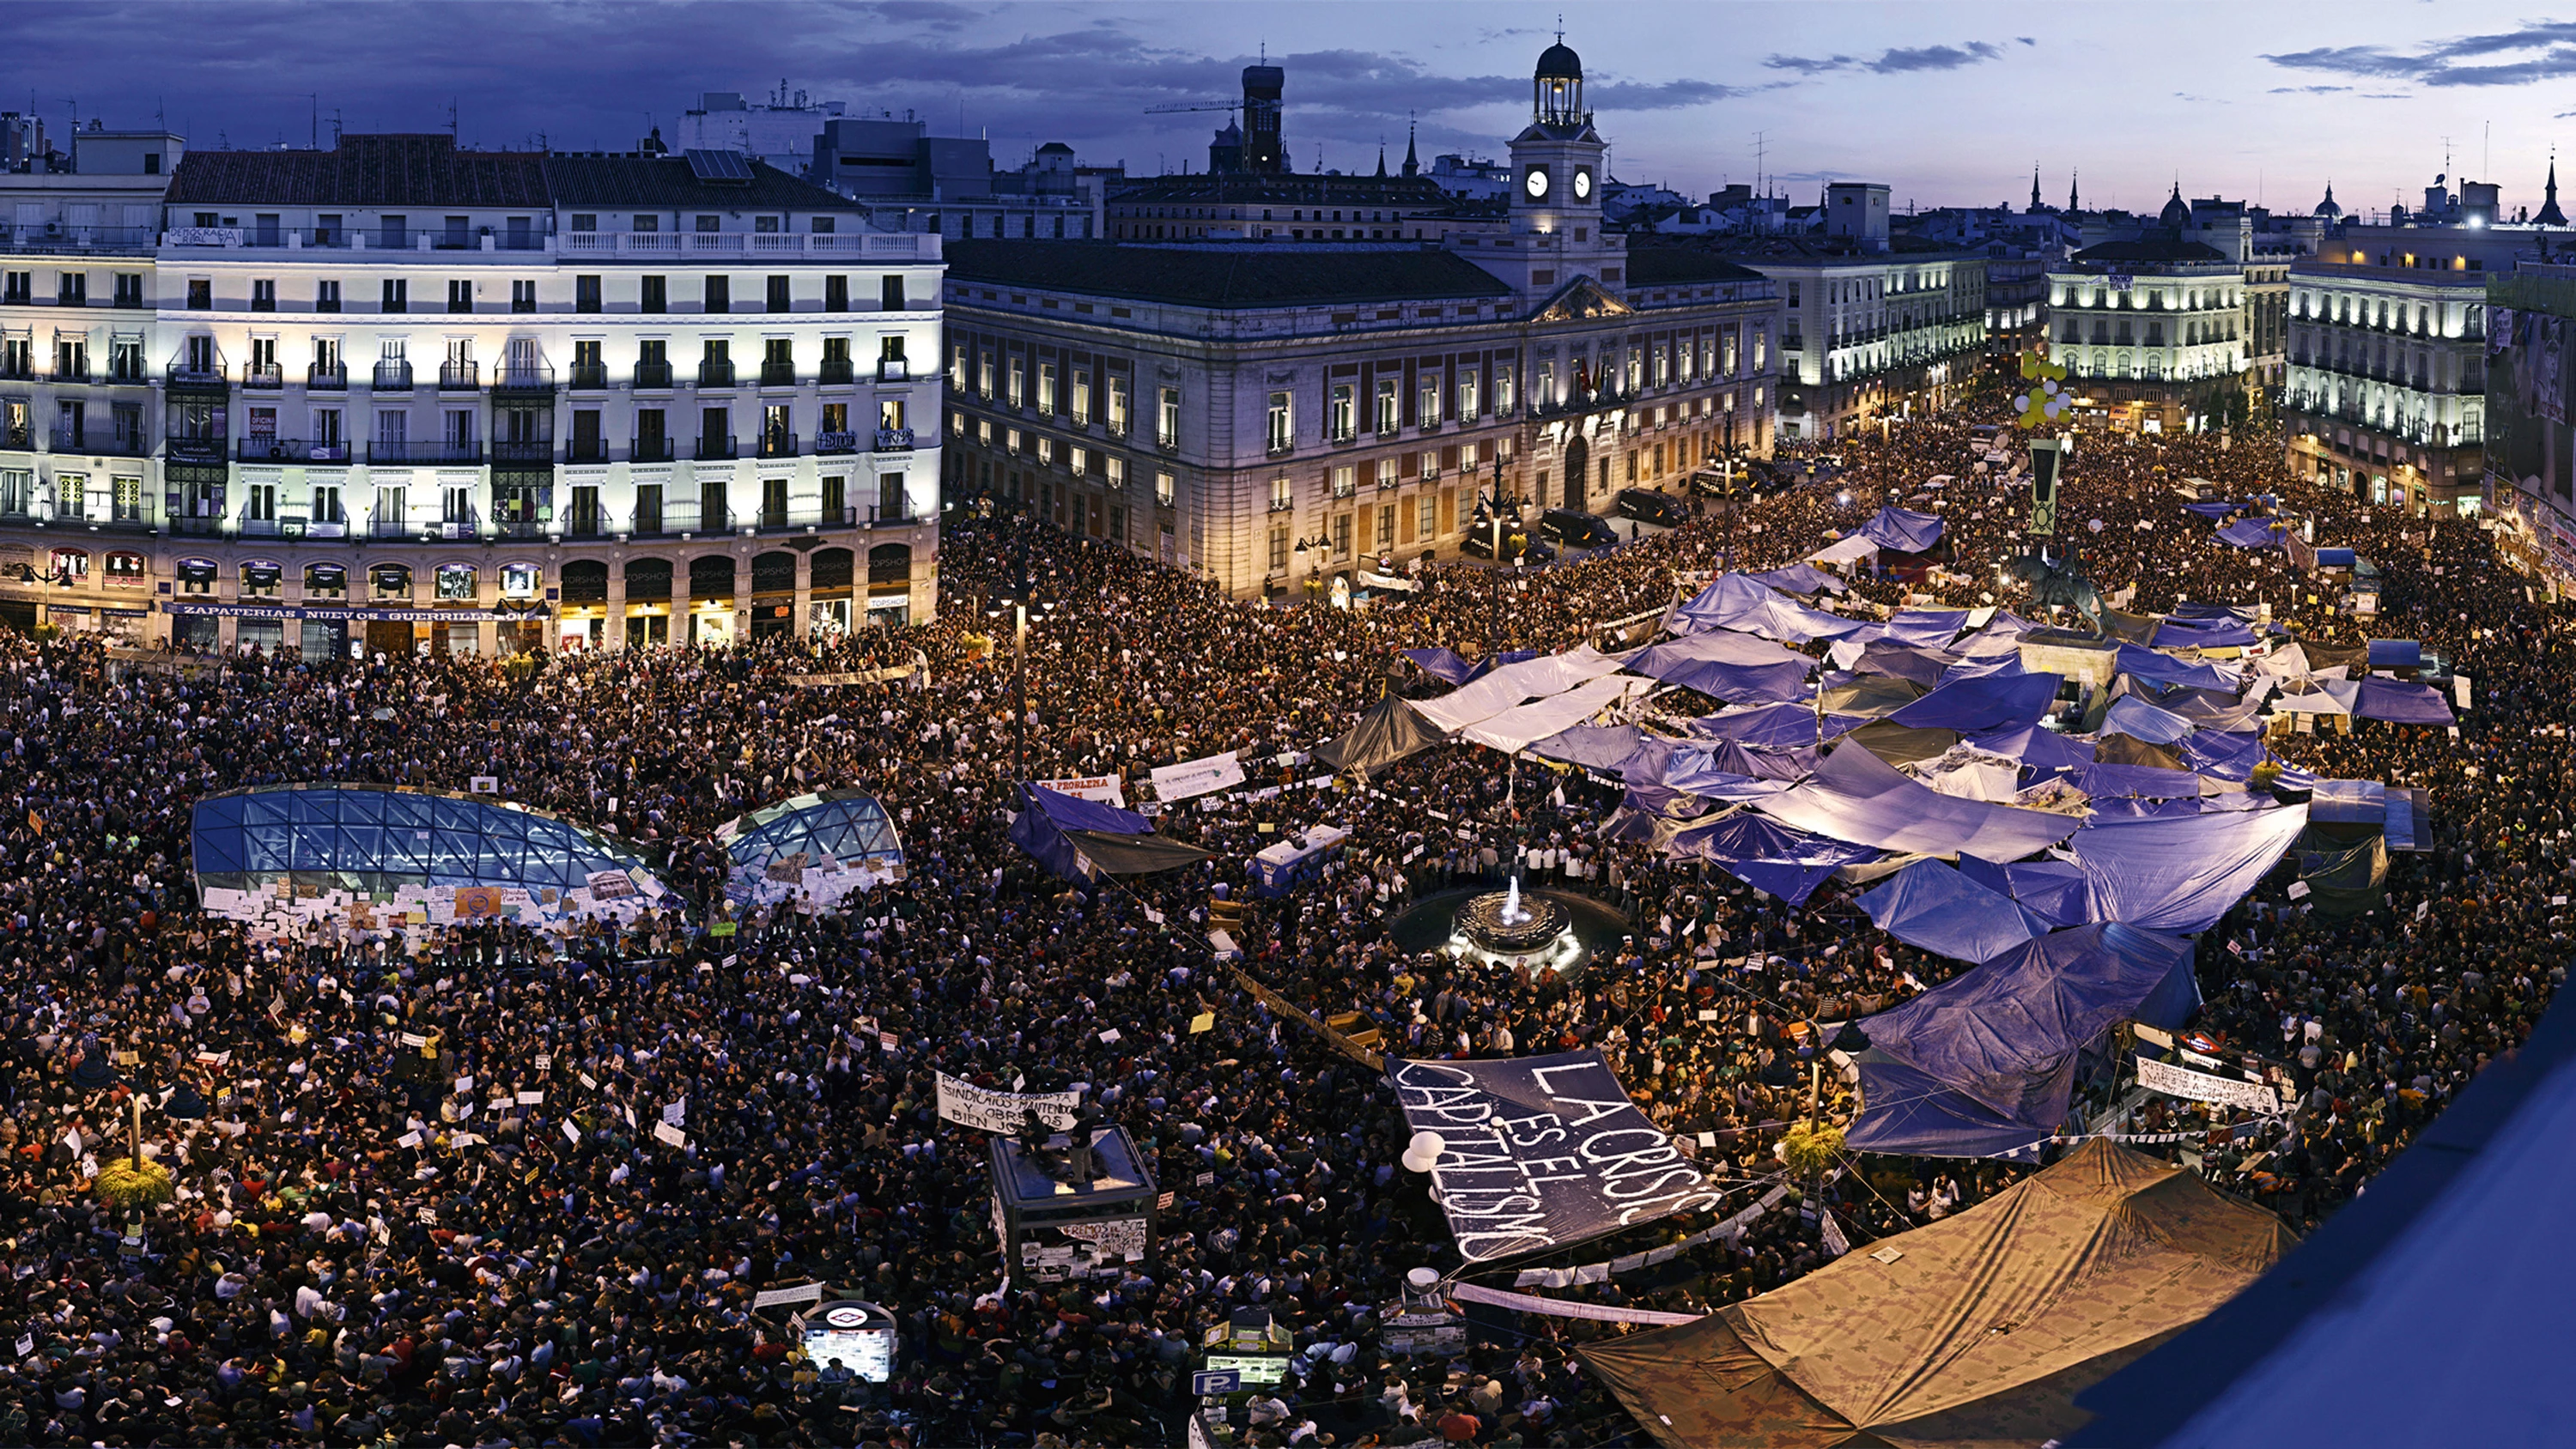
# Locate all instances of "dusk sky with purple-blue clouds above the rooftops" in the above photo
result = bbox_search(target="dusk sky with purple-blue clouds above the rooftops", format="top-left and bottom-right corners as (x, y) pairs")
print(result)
(20, 0), (2576, 222)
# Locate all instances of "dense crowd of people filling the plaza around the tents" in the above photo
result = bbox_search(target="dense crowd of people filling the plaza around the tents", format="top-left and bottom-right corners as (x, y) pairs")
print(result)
(0, 378), (2576, 1449)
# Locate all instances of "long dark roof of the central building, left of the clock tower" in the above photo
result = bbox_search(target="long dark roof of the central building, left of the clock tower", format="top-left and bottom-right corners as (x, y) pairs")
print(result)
(948, 242), (1512, 309)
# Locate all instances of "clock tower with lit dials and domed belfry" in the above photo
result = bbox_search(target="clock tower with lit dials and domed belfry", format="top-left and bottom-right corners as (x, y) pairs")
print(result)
(1479, 33), (1625, 296)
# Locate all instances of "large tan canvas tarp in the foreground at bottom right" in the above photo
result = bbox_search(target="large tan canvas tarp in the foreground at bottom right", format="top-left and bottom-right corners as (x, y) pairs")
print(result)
(1582, 1137), (2293, 1449)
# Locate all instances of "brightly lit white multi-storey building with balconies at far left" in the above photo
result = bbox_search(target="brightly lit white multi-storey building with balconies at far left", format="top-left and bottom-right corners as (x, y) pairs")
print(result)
(0, 134), (940, 652)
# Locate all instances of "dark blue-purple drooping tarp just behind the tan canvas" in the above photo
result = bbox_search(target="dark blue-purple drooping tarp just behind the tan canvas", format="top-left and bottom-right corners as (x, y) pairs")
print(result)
(1844, 921), (2200, 1155)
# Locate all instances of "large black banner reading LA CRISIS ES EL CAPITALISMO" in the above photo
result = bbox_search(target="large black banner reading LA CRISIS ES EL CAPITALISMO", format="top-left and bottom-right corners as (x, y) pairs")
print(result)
(1388, 1052), (1721, 1264)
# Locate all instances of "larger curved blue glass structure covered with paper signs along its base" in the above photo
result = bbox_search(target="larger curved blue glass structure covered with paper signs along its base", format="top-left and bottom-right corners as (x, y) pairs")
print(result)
(191, 785), (662, 926)
